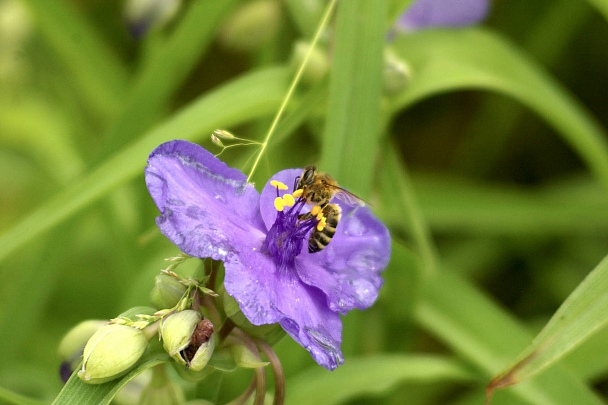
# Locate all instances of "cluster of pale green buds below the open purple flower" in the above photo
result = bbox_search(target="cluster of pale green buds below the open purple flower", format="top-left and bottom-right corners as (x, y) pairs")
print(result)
(59, 255), (285, 404)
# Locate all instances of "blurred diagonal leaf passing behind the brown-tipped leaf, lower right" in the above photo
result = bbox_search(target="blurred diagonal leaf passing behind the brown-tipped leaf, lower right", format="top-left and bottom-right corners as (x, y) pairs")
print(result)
(415, 271), (603, 405)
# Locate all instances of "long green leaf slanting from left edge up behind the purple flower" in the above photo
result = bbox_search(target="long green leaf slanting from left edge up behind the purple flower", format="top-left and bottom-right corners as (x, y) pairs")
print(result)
(0, 68), (288, 260)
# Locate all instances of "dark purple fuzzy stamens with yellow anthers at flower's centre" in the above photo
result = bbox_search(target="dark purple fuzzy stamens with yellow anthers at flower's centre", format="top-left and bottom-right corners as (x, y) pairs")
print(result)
(263, 180), (326, 269)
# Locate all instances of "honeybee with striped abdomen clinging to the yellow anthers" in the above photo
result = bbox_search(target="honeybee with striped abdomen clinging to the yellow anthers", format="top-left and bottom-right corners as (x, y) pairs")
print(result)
(294, 165), (365, 253)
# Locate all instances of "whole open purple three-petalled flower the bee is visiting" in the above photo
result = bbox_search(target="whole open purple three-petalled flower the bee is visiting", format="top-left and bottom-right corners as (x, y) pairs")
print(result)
(146, 140), (390, 370)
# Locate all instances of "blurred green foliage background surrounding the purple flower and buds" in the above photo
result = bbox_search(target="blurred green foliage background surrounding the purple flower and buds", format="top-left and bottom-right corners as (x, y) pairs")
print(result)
(0, 0), (608, 404)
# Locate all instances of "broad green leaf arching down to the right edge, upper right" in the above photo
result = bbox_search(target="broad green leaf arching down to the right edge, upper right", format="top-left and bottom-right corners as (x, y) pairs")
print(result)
(393, 29), (608, 188)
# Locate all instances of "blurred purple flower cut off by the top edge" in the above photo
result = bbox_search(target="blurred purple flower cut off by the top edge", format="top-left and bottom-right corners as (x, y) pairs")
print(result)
(396, 0), (490, 31)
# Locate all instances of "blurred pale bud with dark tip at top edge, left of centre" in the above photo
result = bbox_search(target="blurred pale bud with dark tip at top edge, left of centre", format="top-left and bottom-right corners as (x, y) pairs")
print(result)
(125, 0), (182, 39)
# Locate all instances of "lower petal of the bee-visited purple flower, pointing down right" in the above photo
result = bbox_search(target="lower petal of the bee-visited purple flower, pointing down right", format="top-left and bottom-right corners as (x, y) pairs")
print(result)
(224, 251), (344, 370)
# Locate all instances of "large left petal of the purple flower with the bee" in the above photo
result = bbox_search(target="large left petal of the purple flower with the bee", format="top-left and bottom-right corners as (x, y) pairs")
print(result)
(145, 140), (264, 260)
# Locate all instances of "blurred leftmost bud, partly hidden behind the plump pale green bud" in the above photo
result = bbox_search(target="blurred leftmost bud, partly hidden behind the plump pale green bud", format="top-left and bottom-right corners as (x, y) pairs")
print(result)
(57, 319), (108, 382)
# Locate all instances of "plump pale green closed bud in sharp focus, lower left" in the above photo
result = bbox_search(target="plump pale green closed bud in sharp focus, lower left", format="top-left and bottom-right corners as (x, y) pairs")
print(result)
(78, 324), (148, 384)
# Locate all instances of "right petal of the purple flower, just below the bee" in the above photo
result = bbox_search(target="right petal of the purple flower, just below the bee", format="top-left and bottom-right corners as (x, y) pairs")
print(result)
(295, 199), (391, 314)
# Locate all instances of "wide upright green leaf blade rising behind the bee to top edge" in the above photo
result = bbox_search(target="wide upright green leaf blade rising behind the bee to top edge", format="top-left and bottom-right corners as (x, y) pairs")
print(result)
(320, 0), (388, 197)
